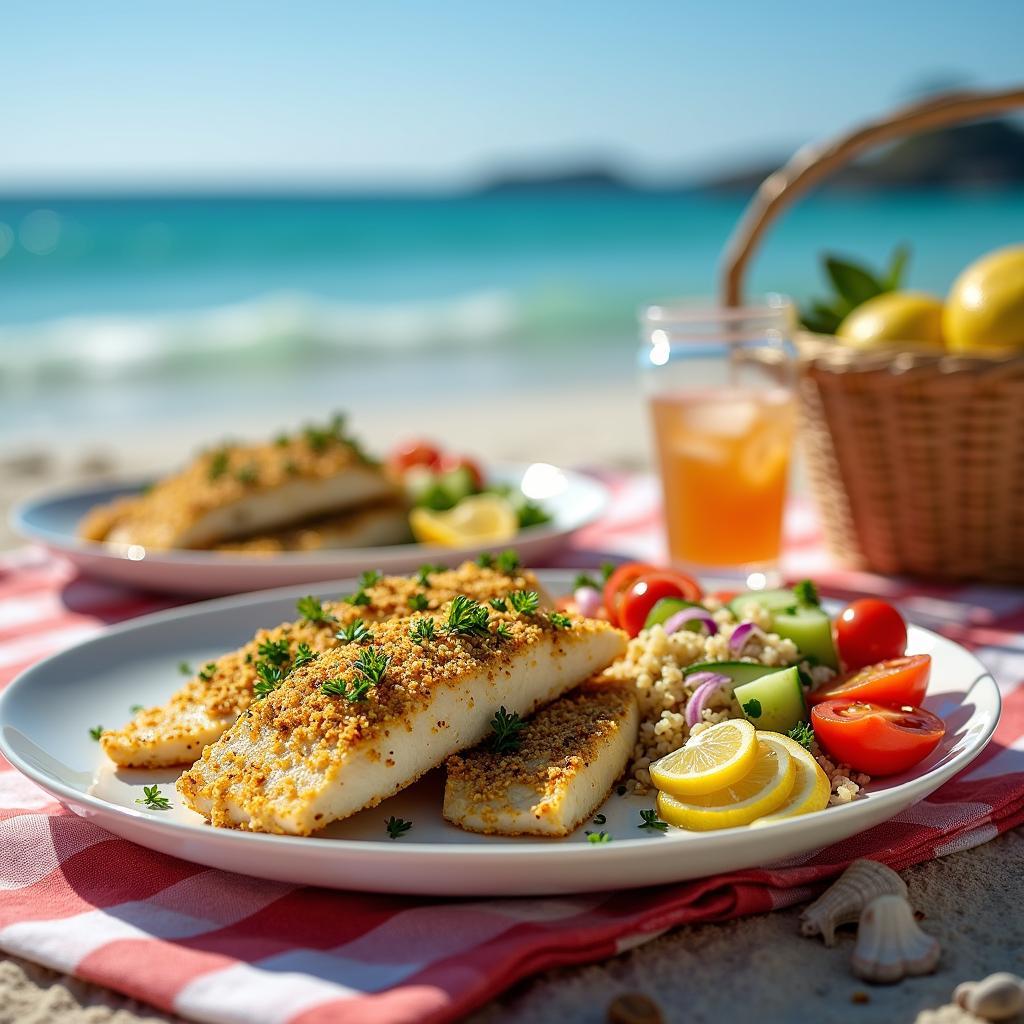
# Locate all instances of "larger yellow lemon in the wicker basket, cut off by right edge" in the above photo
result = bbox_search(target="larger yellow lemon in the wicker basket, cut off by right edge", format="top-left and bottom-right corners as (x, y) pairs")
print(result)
(942, 246), (1024, 352)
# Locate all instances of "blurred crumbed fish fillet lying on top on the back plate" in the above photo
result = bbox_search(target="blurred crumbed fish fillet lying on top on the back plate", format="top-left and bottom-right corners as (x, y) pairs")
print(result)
(79, 420), (398, 551)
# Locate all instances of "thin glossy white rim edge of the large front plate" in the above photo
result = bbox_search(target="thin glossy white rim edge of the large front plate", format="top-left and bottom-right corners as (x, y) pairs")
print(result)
(0, 568), (1002, 860)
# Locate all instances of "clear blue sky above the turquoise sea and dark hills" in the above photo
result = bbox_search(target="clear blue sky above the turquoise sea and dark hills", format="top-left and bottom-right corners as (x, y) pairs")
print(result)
(0, 0), (1024, 189)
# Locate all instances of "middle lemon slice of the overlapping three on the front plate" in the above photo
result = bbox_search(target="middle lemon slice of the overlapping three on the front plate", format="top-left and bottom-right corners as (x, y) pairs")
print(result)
(657, 723), (797, 831)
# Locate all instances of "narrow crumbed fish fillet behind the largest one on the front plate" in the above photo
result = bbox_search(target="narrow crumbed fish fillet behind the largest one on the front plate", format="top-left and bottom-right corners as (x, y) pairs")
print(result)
(100, 556), (550, 768)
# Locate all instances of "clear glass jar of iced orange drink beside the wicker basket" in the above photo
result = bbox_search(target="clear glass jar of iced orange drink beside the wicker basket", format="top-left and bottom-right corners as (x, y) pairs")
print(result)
(640, 296), (797, 586)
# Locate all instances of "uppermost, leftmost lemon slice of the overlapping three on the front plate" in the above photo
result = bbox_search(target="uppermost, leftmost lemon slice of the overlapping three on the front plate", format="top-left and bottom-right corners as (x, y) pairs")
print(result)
(648, 718), (758, 797)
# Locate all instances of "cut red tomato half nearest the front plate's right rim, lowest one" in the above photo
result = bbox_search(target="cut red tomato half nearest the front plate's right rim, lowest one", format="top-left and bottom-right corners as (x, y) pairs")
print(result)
(811, 697), (946, 775)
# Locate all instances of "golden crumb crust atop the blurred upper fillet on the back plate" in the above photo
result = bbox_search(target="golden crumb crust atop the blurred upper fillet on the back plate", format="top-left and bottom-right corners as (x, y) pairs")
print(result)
(79, 426), (397, 550)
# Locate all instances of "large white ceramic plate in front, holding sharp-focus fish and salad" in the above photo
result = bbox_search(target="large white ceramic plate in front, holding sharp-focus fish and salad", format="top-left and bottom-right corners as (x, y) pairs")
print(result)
(0, 571), (999, 896)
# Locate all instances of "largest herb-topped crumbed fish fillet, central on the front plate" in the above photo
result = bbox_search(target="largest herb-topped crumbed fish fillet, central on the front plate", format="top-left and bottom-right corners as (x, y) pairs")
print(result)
(178, 598), (626, 836)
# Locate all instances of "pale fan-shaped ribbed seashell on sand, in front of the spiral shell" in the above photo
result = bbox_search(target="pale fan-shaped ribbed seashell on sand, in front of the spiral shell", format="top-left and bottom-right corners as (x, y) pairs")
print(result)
(851, 895), (939, 982)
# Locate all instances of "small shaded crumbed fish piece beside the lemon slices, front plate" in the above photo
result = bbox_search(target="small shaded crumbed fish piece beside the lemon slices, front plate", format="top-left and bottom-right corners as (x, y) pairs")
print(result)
(443, 682), (640, 836)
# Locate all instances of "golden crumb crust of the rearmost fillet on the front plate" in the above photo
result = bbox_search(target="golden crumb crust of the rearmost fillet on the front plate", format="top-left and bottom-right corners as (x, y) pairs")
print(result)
(100, 562), (540, 764)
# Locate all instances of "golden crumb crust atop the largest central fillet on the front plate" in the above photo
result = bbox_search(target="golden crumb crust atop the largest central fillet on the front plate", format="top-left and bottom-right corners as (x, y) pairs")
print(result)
(177, 605), (610, 831)
